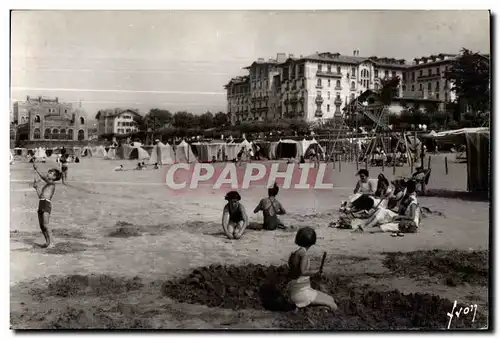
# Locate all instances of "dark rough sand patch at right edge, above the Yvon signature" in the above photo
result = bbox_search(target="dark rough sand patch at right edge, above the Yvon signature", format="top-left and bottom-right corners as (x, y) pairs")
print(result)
(384, 250), (489, 286)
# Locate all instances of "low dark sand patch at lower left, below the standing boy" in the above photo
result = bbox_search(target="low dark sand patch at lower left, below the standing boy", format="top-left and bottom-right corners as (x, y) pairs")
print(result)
(30, 275), (143, 299)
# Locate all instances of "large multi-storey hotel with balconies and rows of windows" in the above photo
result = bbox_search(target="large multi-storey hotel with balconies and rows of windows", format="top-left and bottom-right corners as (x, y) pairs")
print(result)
(224, 51), (457, 124)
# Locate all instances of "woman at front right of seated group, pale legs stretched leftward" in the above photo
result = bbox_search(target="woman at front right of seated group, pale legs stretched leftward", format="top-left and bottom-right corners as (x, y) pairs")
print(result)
(356, 181), (420, 235)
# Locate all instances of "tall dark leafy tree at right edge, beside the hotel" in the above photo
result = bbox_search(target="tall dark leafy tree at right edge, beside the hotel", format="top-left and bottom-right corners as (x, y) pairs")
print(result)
(445, 48), (490, 112)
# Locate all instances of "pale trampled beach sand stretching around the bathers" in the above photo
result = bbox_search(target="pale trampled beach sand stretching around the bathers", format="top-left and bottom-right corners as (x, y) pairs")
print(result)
(10, 154), (490, 329)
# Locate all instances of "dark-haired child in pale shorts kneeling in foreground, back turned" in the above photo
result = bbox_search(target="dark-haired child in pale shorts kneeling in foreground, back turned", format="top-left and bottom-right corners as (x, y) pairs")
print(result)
(288, 227), (337, 311)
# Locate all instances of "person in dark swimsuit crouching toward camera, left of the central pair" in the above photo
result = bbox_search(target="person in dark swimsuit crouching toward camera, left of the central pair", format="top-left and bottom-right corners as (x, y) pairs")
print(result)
(222, 191), (248, 239)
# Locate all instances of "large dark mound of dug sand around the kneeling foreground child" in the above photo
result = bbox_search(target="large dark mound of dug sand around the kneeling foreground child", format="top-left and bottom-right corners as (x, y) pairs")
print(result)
(162, 265), (485, 329)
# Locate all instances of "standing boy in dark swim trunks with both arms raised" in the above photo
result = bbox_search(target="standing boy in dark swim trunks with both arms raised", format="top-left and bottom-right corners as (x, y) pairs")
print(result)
(33, 164), (62, 248)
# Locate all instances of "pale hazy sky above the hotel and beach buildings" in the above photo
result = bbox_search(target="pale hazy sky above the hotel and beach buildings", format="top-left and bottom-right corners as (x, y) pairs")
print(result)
(11, 11), (490, 117)
